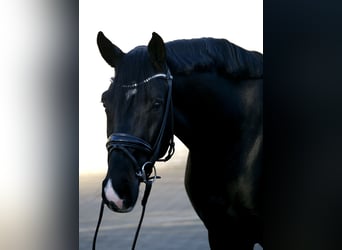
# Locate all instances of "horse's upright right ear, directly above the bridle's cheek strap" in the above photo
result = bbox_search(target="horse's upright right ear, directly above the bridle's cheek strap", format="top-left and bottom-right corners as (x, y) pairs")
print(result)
(148, 32), (166, 71)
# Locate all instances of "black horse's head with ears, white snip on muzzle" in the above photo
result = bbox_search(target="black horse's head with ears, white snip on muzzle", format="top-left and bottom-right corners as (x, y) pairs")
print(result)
(97, 32), (173, 212)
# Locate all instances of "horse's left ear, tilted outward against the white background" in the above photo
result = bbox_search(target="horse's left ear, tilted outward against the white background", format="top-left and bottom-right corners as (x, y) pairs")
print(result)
(97, 31), (125, 68)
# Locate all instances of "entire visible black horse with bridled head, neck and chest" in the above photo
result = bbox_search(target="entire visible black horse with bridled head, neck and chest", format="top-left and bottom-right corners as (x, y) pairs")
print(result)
(97, 32), (263, 249)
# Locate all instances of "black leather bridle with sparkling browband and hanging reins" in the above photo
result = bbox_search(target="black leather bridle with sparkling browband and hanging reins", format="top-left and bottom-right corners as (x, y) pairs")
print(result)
(92, 70), (175, 250)
